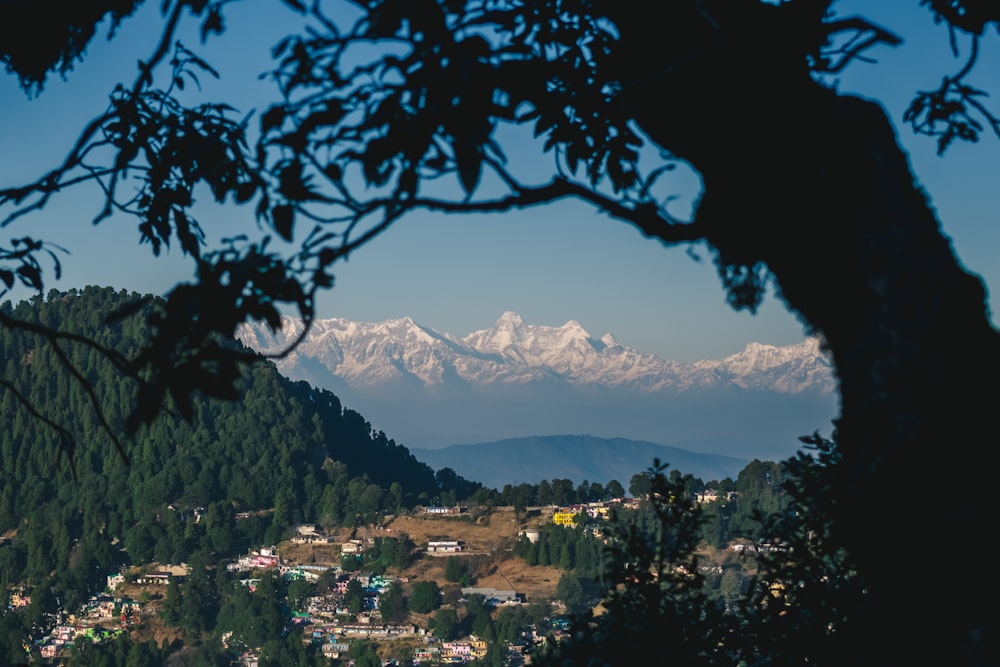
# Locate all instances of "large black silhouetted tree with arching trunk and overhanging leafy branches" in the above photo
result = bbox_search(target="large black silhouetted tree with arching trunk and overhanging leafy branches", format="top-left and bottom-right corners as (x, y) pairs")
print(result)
(0, 0), (1000, 665)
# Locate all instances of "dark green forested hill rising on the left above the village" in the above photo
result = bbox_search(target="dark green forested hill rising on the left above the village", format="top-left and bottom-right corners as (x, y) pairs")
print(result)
(0, 287), (476, 612)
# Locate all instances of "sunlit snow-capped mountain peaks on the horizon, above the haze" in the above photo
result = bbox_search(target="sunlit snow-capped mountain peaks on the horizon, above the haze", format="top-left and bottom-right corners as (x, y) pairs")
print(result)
(239, 312), (835, 395)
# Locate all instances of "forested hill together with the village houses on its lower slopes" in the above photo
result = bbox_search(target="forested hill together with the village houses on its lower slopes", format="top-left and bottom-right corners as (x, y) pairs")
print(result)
(0, 288), (784, 667)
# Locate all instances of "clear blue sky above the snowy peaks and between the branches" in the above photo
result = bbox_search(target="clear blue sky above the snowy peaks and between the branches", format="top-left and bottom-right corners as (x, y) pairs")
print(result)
(0, 0), (1000, 361)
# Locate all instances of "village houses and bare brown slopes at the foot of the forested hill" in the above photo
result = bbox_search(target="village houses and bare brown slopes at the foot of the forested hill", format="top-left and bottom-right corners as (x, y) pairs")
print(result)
(10, 497), (756, 667)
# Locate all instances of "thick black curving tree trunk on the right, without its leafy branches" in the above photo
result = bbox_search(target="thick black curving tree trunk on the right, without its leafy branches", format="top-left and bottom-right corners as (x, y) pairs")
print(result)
(636, 67), (1000, 665)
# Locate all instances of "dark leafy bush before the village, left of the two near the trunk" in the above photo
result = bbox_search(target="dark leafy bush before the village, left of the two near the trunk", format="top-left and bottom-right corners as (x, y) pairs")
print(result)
(531, 462), (736, 665)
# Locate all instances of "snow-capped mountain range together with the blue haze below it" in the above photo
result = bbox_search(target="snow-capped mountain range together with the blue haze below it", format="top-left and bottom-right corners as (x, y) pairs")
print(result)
(238, 312), (836, 460)
